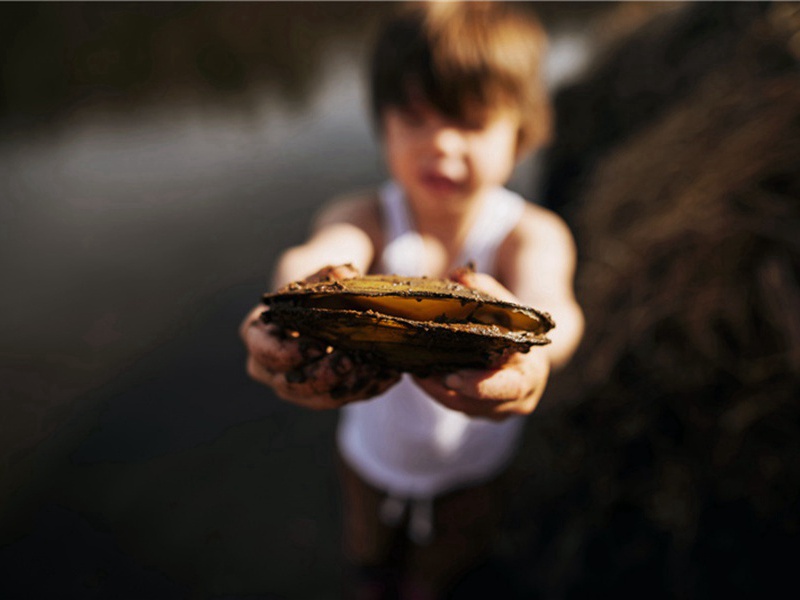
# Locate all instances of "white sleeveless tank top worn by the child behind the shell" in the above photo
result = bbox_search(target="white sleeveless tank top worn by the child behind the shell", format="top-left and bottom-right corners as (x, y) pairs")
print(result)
(337, 182), (525, 499)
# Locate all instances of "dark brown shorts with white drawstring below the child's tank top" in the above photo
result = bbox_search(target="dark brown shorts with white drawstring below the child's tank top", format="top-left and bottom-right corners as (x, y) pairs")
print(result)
(339, 457), (507, 598)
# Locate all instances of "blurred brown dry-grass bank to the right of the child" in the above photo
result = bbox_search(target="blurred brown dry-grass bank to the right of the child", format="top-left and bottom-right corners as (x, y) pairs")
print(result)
(515, 3), (800, 598)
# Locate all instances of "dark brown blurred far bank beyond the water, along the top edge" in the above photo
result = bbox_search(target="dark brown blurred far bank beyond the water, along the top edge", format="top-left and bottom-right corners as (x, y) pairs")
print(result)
(0, 2), (624, 131)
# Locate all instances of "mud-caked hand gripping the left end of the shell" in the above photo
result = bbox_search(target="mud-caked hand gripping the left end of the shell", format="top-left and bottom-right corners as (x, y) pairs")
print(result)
(239, 265), (400, 409)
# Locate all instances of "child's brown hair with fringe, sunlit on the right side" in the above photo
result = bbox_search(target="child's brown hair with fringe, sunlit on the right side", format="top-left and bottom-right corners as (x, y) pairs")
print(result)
(370, 2), (551, 153)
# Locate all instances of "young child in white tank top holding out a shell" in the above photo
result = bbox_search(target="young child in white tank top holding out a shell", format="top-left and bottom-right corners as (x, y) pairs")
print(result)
(242, 2), (583, 598)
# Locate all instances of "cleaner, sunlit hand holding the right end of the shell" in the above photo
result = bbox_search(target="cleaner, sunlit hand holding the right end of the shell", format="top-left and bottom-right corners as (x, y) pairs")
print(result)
(415, 269), (550, 421)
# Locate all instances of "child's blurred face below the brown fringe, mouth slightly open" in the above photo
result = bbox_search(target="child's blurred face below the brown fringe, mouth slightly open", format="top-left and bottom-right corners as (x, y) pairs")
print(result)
(383, 101), (520, 209)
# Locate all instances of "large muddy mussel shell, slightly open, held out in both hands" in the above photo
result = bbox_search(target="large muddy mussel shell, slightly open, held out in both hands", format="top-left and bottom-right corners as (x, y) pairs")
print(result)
(263, 275), (555, 375)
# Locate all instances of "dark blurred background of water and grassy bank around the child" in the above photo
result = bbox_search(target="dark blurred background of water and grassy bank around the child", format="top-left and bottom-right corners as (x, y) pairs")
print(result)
(0, 2), (800, 599)
